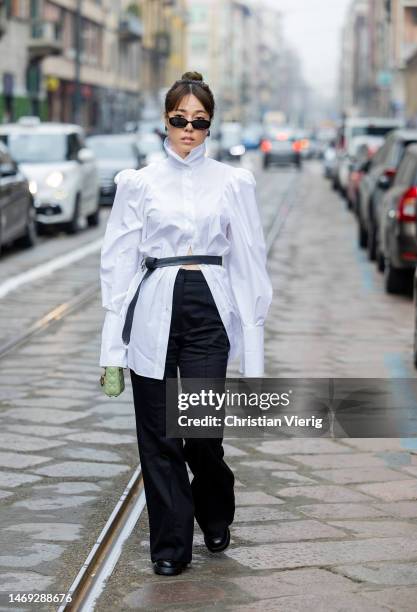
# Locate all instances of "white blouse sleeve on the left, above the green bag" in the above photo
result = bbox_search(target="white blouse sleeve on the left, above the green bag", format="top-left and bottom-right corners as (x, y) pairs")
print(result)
(100, 170), (146, 368)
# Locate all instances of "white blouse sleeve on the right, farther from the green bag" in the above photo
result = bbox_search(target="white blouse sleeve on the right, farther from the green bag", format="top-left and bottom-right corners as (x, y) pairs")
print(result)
(225, 168), (273, 377)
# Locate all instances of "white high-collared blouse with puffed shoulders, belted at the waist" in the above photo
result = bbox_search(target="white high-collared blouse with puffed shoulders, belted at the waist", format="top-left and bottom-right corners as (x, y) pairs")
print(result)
(100, 138), (273, 380)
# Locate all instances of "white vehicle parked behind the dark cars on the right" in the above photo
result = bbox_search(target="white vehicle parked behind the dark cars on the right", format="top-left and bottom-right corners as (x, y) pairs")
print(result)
(333, 117), (404, 195)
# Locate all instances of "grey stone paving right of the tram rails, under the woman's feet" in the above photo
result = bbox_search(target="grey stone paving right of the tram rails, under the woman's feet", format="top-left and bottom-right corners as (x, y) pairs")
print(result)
(97, 165), (417, 612)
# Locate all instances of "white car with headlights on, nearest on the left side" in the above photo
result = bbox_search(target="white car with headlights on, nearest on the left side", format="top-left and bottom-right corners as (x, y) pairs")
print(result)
(0, 117), (100, 234)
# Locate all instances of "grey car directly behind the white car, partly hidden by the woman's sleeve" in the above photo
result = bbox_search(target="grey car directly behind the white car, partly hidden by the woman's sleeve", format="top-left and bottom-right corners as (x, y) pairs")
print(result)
(86, 134), (143, 204)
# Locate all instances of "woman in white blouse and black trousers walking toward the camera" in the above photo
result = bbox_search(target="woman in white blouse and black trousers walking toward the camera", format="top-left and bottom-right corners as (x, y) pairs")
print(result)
(100, 72), (272, 575)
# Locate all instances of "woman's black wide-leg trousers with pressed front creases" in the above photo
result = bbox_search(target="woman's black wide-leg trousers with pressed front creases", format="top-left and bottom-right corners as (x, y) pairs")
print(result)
(130, 268), (235, 563)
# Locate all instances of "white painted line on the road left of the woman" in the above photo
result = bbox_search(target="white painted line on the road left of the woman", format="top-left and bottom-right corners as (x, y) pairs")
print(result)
(0, 238), (103, 298)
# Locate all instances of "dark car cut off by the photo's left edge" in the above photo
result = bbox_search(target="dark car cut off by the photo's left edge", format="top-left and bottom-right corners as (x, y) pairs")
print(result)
(0, 142), (37, 250)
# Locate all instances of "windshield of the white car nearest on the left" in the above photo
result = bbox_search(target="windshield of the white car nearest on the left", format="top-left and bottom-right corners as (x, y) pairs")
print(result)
(0, 132), (68, 164)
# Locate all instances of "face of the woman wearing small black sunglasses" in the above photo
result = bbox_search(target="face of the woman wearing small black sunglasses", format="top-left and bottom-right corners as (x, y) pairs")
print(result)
(165, 94), (210, 157)
